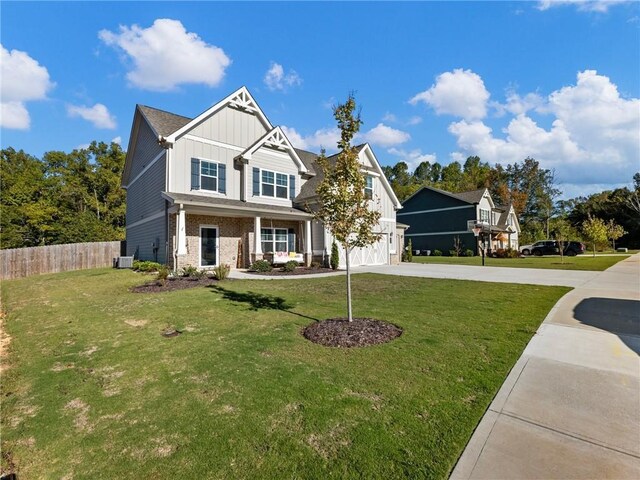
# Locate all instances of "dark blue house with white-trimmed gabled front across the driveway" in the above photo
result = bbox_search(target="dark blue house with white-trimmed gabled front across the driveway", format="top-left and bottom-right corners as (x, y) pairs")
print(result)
(398, 187), (520, 254)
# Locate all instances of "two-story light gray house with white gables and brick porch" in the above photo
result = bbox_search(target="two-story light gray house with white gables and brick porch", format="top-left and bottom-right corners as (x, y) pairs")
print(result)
(122, 87), (404, 269)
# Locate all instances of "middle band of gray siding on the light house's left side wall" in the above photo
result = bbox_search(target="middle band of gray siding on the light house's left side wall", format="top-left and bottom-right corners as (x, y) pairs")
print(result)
(127, 158), (166, 225)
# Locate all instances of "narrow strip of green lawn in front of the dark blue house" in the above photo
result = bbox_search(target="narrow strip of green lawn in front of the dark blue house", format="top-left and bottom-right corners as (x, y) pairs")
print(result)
(413, 254), (628, 271)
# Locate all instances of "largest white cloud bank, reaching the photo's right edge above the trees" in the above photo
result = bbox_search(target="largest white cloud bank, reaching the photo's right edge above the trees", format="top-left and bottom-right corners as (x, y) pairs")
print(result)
(449, 70), (640, 184)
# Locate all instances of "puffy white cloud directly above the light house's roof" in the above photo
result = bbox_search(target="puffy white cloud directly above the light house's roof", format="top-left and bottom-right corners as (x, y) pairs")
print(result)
(98, 18), (231, 91)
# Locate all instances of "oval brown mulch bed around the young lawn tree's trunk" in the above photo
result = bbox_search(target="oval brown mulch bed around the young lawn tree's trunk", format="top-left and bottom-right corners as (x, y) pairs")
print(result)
(302, 318), (402, 348)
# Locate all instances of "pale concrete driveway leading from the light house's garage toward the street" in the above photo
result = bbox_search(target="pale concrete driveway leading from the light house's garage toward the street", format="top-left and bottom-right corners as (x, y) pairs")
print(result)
(353, 260), (600, 287)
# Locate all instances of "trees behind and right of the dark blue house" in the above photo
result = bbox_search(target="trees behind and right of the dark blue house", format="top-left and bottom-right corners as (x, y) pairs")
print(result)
(383, 156), (640, 248)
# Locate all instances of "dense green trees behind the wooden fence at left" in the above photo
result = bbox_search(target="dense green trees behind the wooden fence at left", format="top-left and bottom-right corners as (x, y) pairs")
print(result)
(0, 141), (126, 248)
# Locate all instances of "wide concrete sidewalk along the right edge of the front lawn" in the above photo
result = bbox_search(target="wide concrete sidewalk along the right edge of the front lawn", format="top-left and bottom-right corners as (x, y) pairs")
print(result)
(451, 254), (640, 480)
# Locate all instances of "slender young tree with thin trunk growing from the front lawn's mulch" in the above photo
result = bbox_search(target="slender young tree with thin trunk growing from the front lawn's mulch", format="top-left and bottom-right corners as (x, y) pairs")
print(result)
(313, 94), (380, 322)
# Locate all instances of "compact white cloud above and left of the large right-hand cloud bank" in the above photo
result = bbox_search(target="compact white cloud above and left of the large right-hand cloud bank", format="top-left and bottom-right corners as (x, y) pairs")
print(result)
(409, 68), (489, 120)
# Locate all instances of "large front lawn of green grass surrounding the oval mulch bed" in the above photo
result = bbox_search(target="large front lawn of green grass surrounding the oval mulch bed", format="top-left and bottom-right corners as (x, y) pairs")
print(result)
(1, 269), (568, 480)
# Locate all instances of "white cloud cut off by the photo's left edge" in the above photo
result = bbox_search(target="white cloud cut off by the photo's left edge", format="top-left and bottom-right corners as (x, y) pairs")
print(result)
(0, 44), (55, 130)
